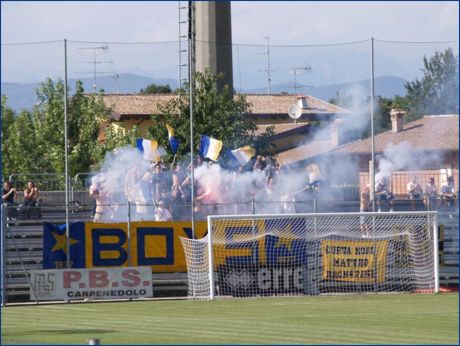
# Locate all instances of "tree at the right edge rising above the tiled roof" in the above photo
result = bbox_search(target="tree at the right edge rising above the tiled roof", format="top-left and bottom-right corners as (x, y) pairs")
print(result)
(405, 48), (459, 121)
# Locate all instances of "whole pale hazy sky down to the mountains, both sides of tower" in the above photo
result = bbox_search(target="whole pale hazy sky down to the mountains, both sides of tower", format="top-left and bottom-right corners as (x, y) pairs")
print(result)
(1, 1), (459, 81)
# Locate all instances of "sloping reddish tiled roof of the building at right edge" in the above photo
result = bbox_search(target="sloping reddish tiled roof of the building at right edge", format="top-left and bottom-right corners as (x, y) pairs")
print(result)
(332, 114), (458, 154)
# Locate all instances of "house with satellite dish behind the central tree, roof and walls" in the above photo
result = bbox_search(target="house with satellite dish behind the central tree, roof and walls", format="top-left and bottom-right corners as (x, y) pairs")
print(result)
(103, 94), (351, 152)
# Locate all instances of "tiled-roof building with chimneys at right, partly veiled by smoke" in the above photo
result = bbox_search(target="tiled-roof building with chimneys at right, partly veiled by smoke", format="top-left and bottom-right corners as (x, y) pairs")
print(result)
(278, 110), (459, 196)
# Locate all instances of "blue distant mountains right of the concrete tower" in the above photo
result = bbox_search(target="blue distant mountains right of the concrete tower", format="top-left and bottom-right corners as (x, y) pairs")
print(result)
(238, 76), (406, 101)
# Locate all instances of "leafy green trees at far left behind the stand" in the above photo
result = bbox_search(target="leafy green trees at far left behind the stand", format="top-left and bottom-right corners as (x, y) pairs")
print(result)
(2, 79), (138, 177)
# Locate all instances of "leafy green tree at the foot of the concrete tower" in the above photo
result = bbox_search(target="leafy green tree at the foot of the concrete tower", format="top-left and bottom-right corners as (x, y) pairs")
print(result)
(148, 70), (273, 161)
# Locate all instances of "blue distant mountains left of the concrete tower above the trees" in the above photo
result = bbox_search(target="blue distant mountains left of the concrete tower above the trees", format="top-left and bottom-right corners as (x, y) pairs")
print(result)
(1, 73), (177, 112)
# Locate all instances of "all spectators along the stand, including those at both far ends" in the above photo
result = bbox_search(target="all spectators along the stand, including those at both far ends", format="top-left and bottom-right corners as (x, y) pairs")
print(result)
(2, 156), (456, 222)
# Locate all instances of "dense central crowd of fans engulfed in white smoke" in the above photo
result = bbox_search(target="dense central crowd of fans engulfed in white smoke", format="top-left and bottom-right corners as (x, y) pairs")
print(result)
(90, 156), (324, 222)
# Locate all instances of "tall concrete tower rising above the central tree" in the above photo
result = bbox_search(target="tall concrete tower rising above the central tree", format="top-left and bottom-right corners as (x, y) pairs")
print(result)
(194, 1), (233, 91)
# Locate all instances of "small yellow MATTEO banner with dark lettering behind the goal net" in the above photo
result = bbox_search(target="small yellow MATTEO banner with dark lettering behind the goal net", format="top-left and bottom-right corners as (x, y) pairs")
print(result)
(321, 240), (388, 283)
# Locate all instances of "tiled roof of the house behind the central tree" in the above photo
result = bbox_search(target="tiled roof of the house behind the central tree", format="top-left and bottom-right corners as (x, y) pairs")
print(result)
(103, 94), (350, 120)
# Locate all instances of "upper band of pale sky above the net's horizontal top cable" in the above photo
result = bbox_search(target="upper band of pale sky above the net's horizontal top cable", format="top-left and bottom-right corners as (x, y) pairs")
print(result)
(1, 1), (459, 44)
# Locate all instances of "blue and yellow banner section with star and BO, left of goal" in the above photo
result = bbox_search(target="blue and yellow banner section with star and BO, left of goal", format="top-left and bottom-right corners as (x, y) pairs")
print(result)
(43, 221), (207, 273)
